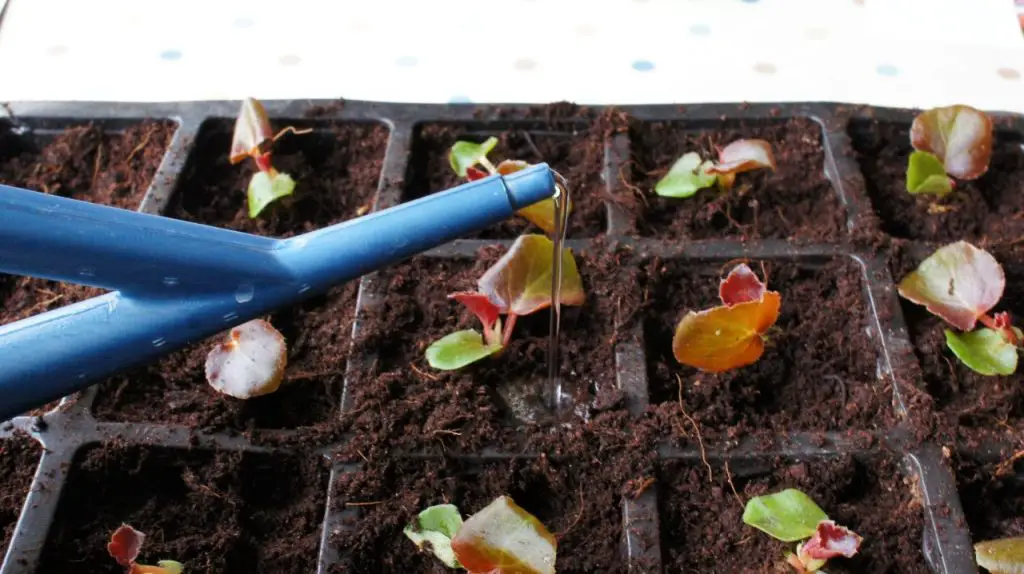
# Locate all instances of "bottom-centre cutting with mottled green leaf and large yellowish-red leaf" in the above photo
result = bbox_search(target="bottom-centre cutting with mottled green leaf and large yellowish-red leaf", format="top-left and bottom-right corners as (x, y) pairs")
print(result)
(404, 496), (558, 574)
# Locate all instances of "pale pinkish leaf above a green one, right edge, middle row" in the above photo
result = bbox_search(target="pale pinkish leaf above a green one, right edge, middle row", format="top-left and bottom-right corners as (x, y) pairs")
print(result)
(898, 241), (1006, 332)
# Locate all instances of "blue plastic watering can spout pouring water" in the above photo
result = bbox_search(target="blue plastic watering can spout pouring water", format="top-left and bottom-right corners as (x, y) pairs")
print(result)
(0, 164), (555, 421)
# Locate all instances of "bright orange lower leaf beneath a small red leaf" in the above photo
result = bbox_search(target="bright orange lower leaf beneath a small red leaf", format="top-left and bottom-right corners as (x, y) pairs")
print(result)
(672, 291), (781, 372)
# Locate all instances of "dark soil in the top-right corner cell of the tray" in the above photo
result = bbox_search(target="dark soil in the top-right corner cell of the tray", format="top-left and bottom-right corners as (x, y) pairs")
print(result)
(850, 121), (1024, 245)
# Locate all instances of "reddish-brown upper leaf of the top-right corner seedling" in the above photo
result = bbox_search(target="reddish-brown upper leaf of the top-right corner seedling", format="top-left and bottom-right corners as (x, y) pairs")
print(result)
(910, 105), (992, 179)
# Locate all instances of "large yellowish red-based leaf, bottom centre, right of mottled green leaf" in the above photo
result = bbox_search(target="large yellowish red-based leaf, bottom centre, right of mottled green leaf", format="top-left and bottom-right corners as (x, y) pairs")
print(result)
(452, 496), (558, 574)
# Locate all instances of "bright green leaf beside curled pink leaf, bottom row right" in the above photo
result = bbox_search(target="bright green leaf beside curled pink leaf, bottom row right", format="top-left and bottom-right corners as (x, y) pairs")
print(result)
(743, 488), (828, 542)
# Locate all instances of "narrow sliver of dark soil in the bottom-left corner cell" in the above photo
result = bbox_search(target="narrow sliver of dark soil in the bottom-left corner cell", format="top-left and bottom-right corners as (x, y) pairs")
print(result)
(0, 436), (42, 563)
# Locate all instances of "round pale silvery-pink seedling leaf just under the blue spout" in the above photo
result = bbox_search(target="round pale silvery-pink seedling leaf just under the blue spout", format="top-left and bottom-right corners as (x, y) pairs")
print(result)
(206, 319), (288, 399)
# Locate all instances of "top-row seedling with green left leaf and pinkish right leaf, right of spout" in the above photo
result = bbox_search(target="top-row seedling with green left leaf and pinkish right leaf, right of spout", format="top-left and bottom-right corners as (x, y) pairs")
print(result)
(654, 139), (775, 197)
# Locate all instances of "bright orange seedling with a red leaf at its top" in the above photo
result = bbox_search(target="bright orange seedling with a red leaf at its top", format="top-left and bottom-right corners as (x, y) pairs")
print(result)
(672, 264), (782, 372)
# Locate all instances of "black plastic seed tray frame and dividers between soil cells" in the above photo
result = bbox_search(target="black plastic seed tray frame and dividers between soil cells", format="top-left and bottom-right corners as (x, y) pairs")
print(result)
(0, 100), (1024, 574)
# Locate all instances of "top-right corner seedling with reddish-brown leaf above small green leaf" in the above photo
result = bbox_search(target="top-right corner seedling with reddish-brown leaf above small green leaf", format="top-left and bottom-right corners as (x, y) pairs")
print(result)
(906, 105), (992, 196)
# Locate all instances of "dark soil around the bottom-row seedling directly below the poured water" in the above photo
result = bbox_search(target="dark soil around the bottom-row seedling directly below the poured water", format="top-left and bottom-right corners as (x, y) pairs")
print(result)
(332, 457), (628, 574)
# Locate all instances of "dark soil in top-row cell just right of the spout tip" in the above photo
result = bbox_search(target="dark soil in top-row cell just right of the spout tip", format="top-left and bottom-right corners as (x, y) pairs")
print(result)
(624, 118), (846, 242)
